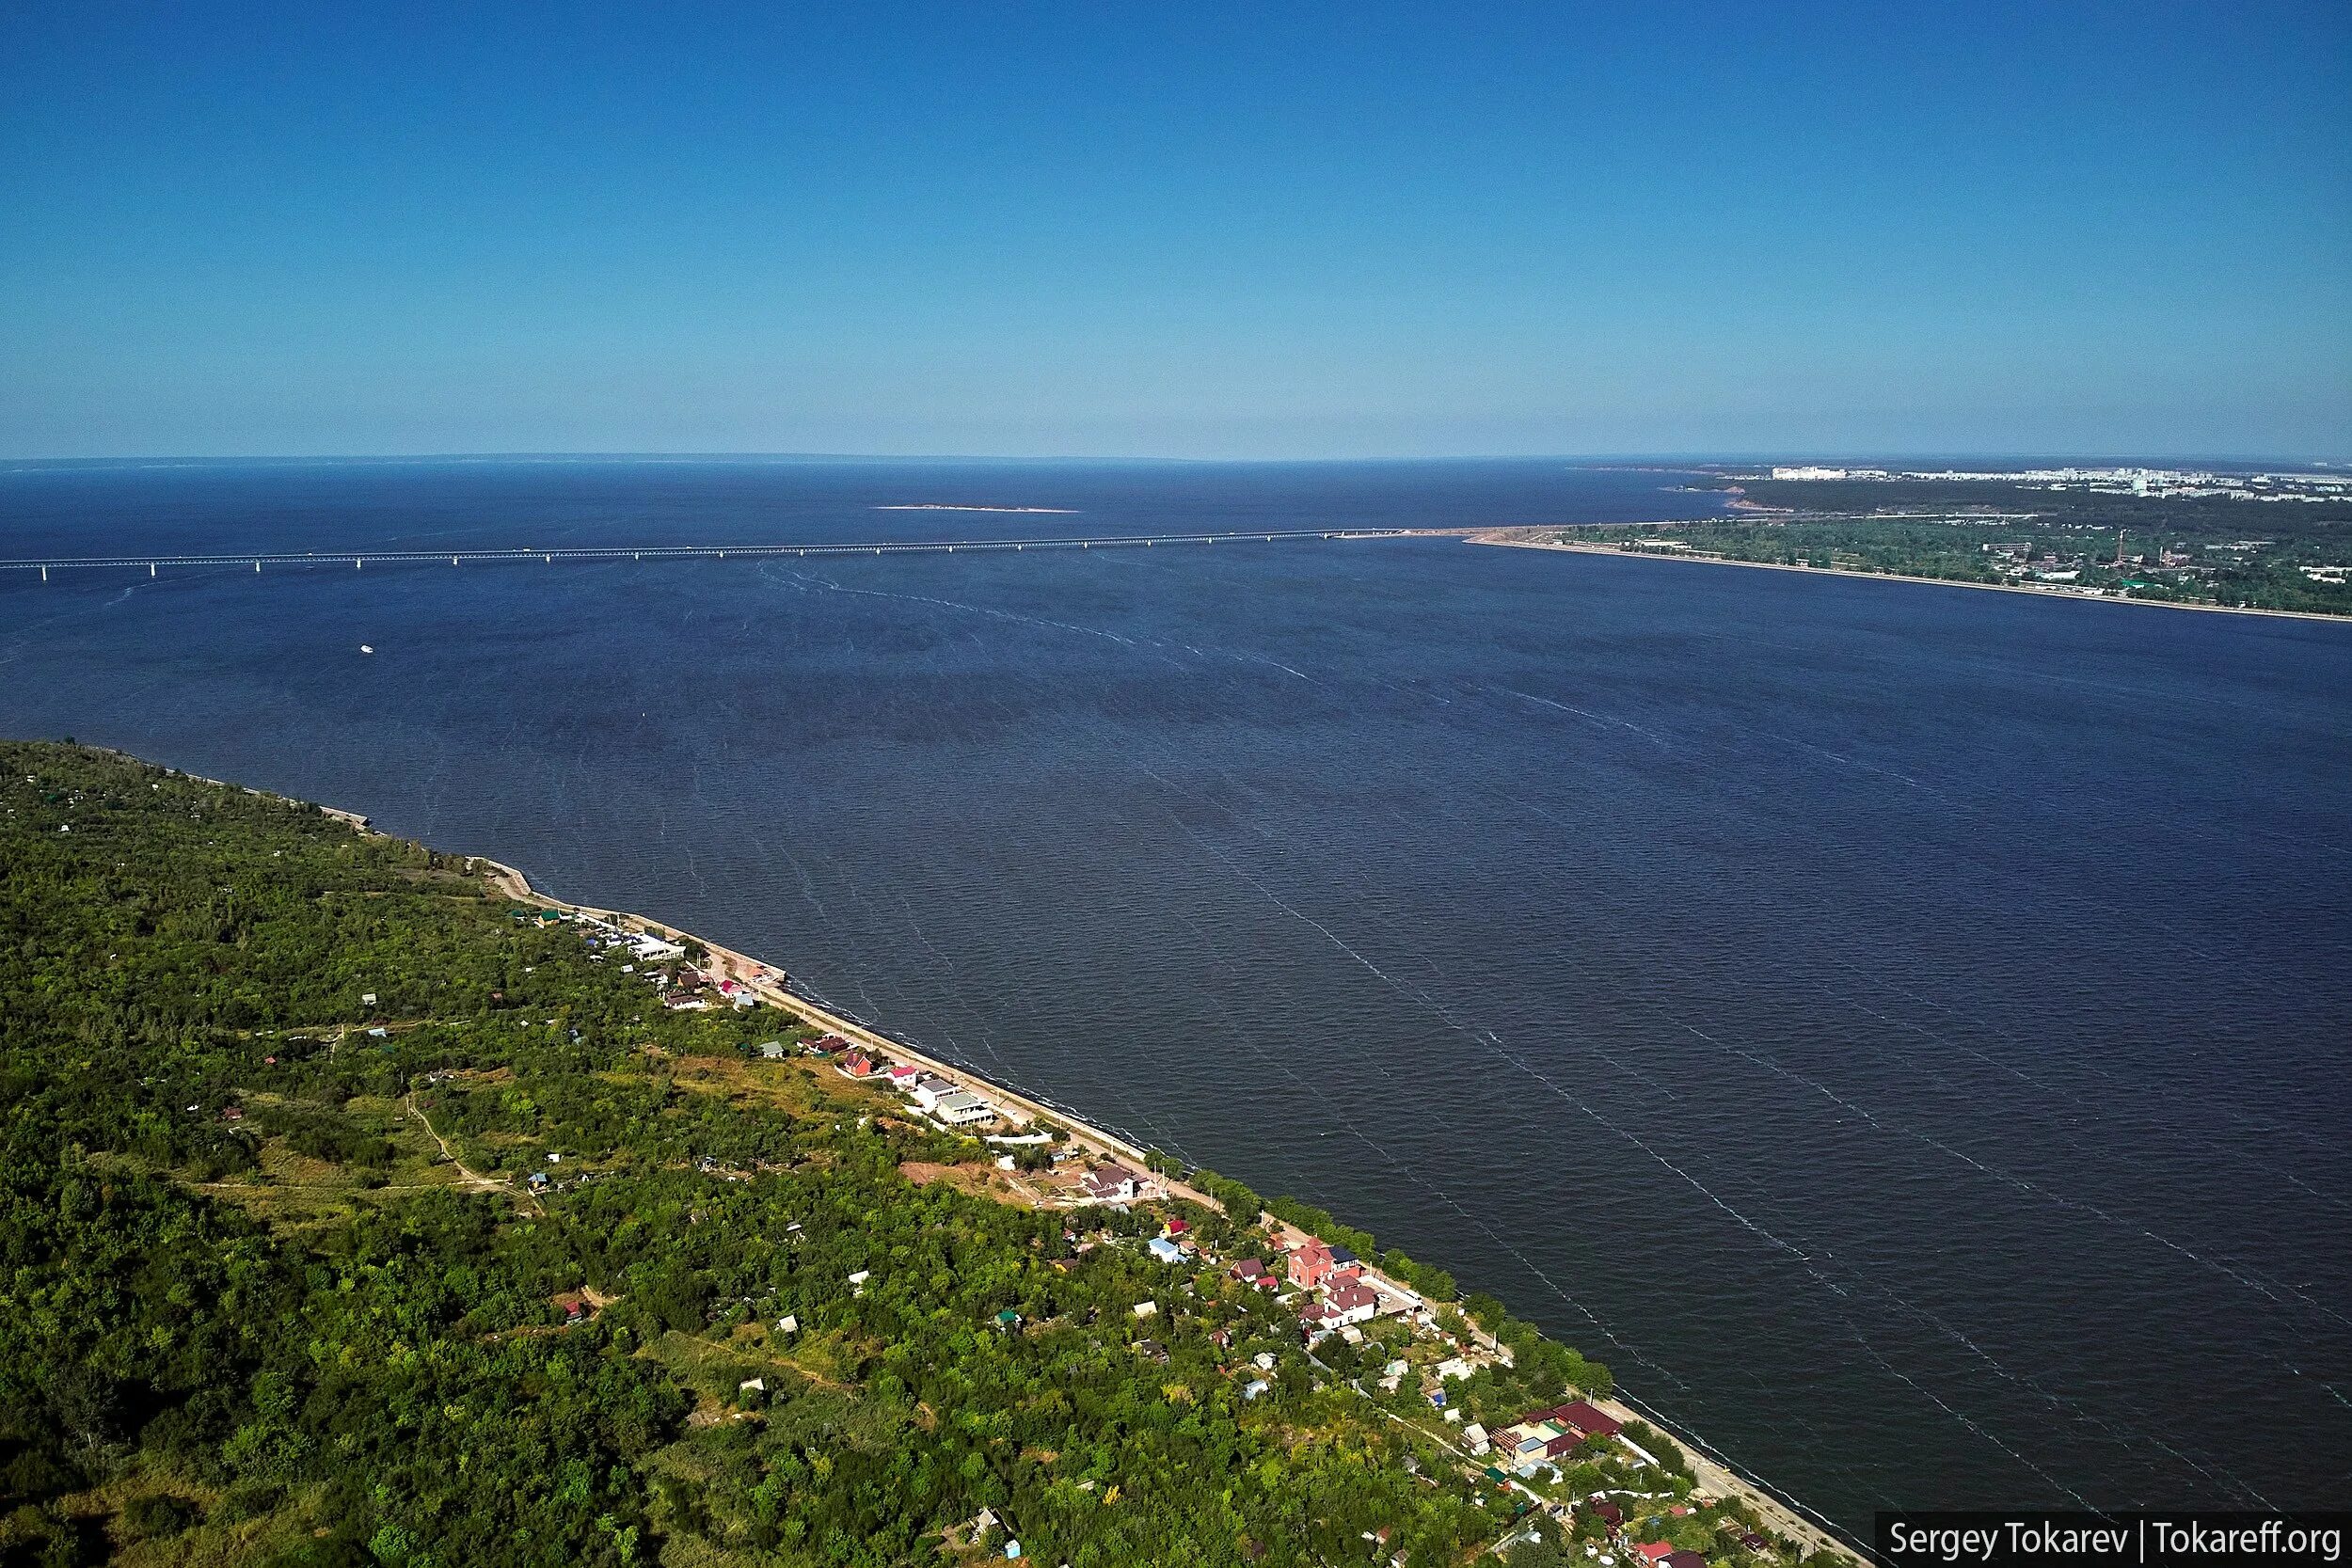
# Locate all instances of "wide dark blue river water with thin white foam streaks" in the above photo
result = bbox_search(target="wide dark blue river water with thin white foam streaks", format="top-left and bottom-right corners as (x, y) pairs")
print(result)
(0, 463), (2352, 1530)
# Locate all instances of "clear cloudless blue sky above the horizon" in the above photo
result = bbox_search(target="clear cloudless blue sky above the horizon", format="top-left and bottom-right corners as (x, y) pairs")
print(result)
(0, 0), (2352, 458)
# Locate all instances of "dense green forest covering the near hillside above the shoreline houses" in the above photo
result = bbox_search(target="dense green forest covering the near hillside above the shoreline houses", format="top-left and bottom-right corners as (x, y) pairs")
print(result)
(0, 743), (1778, 1568)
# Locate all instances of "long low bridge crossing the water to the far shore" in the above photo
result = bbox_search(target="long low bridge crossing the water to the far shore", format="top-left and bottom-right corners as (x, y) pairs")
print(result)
(0, 529), (1472, 580)
